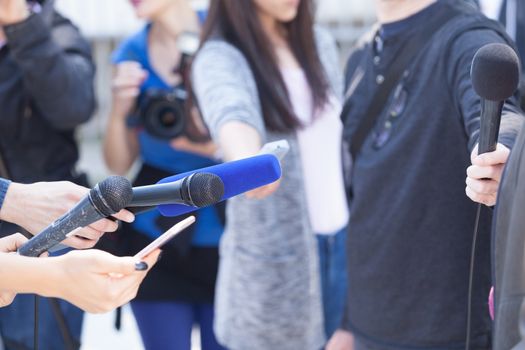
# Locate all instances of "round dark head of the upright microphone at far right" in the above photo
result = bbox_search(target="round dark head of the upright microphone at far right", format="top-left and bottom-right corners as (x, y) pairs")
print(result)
(470, 44), (520, 102)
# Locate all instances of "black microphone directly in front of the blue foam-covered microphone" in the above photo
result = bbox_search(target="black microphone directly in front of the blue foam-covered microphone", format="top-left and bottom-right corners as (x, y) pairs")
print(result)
(129, 173), (224, 208)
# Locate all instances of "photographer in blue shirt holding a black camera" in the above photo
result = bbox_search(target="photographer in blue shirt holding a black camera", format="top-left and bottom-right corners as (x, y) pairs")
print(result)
(104, 0), (224, 350)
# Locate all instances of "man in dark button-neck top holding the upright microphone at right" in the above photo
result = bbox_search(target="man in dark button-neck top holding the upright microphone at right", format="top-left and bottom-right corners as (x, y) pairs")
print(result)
(329, 0), (523, 350)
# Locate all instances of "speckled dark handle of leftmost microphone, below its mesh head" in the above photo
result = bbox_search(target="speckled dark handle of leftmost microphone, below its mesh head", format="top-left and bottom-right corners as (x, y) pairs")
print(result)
(18, 195), (104, 257)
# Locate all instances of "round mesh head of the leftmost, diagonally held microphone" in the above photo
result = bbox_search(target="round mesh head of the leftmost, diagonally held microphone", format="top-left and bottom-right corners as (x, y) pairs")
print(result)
(90, 176), (133, 217)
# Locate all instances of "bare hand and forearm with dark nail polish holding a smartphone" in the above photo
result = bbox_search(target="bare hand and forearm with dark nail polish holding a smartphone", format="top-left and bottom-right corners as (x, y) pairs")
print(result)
(0, 234), (160, 313)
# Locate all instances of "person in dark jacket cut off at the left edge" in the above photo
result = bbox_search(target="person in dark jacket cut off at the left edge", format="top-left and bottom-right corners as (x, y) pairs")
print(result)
(0, 0), (95, 349)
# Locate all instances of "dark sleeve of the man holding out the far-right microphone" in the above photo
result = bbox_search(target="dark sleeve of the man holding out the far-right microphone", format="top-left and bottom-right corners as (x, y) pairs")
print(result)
(446, 29), (523, 150)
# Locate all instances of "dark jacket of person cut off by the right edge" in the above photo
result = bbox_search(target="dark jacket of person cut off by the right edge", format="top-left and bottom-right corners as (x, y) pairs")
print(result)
(493, 123), (525, 350)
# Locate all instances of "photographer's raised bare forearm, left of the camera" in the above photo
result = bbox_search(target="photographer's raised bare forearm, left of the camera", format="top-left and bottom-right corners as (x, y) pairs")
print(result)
(104, 116), (139, 175)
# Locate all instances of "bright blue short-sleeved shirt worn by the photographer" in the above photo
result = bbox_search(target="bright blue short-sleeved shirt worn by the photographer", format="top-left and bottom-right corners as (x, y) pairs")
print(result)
(112, 24), (223, 246)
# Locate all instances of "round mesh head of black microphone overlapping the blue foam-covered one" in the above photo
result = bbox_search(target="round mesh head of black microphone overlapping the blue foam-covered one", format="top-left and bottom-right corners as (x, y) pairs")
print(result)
(188, 173), (224, 208)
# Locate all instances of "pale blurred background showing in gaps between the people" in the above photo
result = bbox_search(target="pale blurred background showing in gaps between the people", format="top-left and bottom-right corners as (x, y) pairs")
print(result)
(50, 0), (375, 350)
